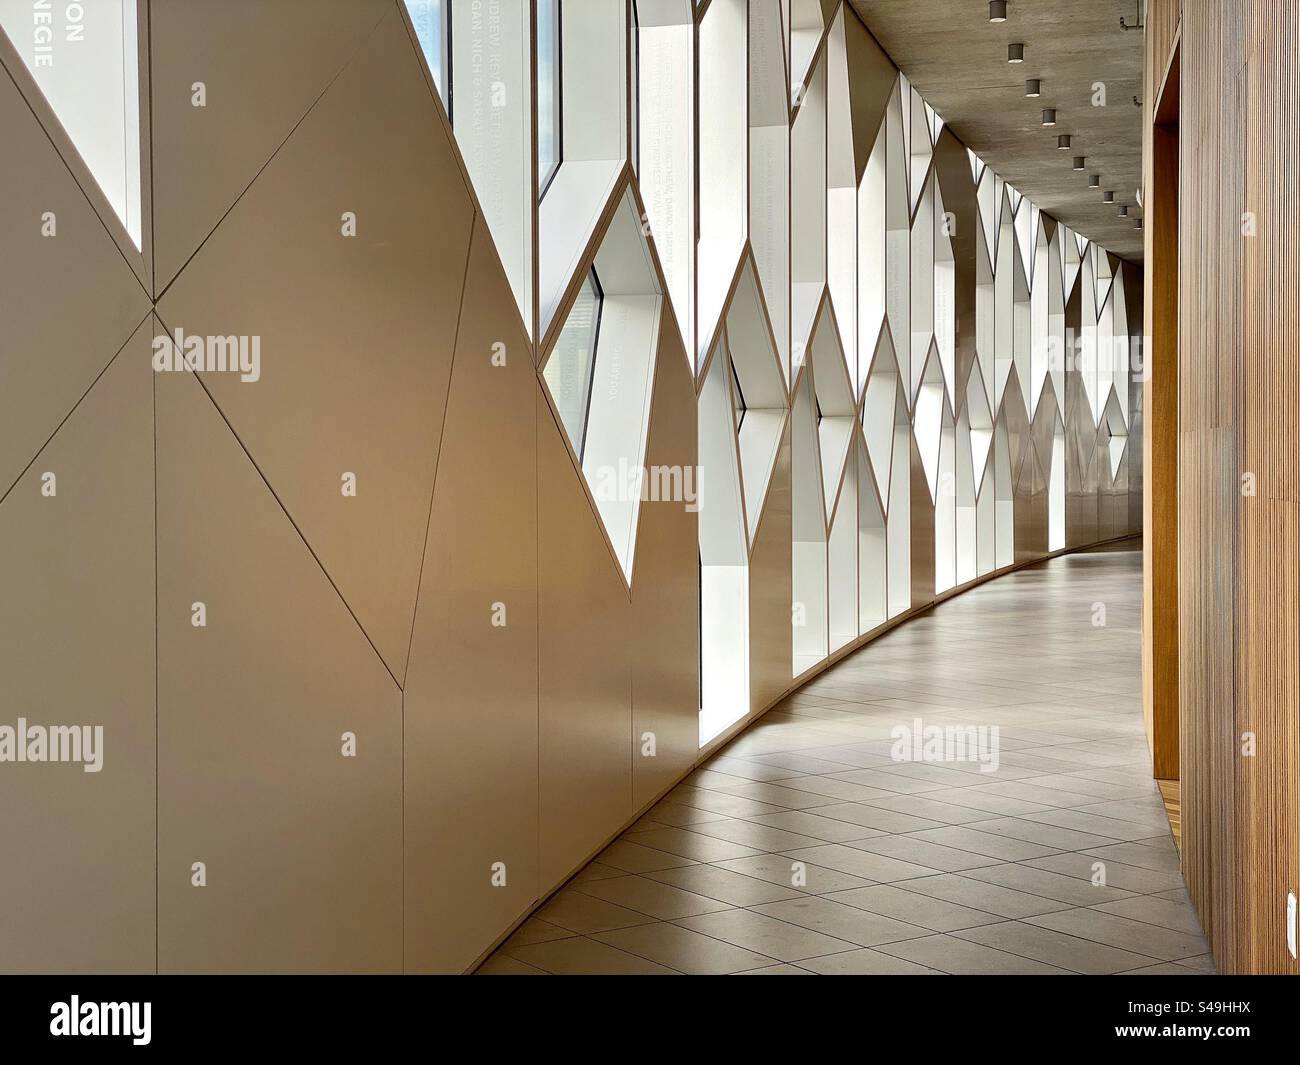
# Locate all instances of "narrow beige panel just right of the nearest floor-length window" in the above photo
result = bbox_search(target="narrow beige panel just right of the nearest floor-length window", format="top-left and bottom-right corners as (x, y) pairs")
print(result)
(754, 420), (794, 711)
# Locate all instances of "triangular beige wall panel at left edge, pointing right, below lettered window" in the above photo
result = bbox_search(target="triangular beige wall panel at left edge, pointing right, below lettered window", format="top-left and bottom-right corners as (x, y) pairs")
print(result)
(0, 51), (150, 497)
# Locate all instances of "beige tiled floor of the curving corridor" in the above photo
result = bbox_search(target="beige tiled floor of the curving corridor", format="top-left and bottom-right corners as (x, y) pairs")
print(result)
(480, 551), (1213, 975)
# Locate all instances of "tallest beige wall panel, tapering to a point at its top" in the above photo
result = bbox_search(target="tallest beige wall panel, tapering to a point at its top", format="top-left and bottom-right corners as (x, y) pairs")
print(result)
(404, 220), (538, 973)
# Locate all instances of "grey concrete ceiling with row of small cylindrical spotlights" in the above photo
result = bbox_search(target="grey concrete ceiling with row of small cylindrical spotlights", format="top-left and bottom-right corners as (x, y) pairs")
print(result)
(850, 0), (1143, 261)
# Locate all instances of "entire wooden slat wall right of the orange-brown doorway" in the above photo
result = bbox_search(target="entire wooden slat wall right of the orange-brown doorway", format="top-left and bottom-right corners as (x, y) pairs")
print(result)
(1147, 0), (1300, 973)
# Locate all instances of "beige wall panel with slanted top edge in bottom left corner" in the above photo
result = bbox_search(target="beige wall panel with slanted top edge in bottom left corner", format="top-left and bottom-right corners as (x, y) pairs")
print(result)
(0, 322), (156, 973)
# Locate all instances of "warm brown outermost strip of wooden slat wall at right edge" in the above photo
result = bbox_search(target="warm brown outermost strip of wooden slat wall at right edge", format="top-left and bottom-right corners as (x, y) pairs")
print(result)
(1235, 0), (1300, 973)
